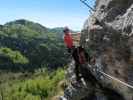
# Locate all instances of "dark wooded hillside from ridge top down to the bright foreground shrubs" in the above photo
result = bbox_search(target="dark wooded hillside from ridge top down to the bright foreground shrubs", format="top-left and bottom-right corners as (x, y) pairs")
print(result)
(0, 19), (67, 70)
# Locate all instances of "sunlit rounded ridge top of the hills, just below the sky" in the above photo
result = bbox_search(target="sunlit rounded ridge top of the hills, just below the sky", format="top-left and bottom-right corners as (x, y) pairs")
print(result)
(0, 19), (63, 37)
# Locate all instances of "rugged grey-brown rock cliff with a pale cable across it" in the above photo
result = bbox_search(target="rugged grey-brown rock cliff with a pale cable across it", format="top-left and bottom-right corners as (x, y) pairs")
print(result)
(64, 0), (133, 100)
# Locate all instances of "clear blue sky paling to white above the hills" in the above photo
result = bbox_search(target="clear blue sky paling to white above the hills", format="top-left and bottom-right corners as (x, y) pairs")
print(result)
(0, 0), (95, 30)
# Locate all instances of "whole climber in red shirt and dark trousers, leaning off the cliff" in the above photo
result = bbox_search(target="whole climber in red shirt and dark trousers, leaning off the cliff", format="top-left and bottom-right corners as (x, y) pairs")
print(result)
(63, 27), (88, 81)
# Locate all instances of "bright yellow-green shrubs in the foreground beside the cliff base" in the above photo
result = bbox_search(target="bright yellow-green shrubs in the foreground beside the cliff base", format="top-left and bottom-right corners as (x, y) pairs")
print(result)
(0, 69), (65, 100)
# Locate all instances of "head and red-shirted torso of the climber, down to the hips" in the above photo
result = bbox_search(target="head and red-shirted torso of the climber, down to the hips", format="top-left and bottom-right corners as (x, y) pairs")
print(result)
(63, 27), (74, 53)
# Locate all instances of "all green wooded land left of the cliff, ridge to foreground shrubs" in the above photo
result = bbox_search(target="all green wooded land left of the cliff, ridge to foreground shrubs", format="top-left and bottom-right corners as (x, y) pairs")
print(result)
(0, 19), (68, 100)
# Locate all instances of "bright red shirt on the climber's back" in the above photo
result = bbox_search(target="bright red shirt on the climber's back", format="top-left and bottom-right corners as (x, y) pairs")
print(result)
(64, 33), (73, 48)
